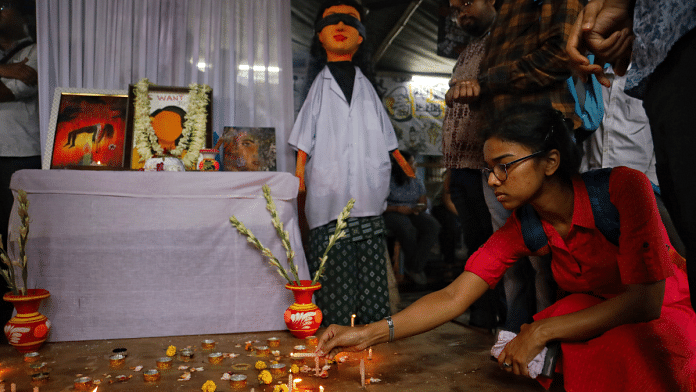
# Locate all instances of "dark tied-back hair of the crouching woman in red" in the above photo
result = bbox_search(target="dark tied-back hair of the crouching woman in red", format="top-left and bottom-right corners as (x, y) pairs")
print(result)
(481, 104), (582, 181)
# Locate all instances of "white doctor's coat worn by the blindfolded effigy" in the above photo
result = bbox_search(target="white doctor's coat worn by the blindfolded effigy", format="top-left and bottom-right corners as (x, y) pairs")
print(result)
(288, 66), (398, 229)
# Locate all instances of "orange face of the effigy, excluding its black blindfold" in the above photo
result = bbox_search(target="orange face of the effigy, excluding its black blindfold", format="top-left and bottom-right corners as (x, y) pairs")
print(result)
(317, 5), (363, 61)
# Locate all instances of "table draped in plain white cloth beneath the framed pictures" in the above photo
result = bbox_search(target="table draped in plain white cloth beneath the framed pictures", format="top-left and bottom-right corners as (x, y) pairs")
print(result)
(10, 170), (309, 341)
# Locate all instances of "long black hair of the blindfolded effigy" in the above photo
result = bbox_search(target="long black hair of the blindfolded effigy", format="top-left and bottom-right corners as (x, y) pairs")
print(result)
(302, 0), (375, 99)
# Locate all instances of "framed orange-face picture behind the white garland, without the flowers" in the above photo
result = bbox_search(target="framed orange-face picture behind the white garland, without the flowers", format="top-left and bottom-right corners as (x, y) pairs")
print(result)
(126, 85), (213, 170)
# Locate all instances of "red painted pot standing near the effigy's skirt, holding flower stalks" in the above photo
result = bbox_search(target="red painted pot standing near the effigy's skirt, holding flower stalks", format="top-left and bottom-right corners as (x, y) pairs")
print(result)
(283, 280), (324, 339)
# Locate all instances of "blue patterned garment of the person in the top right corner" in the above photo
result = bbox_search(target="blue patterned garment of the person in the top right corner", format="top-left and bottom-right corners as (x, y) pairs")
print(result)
(626, 0), (696, 99)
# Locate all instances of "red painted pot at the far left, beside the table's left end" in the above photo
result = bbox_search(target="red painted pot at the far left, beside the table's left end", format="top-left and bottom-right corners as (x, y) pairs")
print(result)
(2, 289), (51, 353)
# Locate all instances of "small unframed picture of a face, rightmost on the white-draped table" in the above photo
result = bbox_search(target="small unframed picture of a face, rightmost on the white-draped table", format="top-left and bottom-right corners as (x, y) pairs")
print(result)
(214, 127), (276, 171)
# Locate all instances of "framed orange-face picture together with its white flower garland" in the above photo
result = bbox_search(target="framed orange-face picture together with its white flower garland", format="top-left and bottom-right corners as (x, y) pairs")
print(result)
(126, 79), (213, 170)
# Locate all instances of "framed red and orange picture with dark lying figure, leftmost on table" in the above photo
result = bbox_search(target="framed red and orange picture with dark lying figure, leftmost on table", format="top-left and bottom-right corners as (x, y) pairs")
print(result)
(42, 87), (128, 170)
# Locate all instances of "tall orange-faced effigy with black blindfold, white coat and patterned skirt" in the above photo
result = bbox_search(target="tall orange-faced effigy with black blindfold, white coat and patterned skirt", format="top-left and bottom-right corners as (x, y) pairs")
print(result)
(288, 0), (414, 325)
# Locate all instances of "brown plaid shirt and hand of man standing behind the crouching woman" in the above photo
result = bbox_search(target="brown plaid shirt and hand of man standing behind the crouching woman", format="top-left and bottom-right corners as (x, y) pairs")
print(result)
(446, 0), (582, 128)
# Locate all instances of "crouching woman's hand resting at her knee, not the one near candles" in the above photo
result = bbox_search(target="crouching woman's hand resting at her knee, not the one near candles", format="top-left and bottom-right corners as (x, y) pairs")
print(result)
(498, 320), (548, 377)
